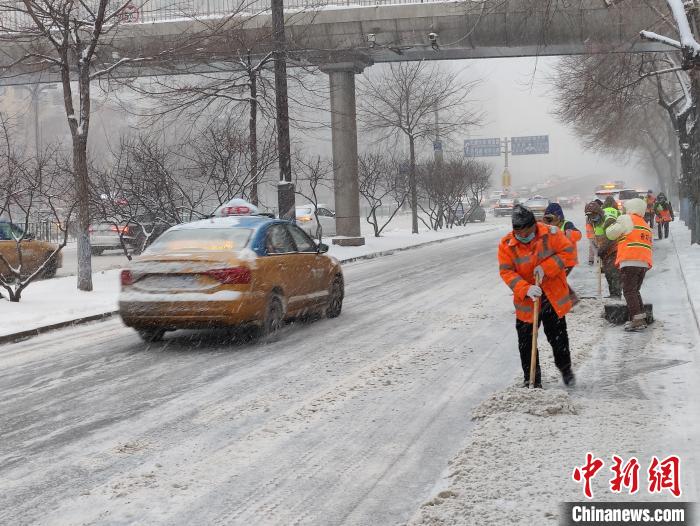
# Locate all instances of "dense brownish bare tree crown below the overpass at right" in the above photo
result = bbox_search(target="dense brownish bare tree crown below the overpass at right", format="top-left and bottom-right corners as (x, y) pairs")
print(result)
(552, 53), (684, 191)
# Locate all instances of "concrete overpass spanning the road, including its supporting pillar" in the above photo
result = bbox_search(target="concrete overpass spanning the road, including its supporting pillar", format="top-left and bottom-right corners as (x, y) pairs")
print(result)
(0, 0), (672, 241)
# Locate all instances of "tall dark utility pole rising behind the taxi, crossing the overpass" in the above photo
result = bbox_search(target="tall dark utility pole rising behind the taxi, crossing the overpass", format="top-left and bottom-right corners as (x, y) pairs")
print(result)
(270, 0), (295, 221)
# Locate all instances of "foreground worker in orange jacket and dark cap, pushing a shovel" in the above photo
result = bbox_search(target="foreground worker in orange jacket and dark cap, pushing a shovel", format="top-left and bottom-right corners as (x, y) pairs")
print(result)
(498, 205), (576, 387)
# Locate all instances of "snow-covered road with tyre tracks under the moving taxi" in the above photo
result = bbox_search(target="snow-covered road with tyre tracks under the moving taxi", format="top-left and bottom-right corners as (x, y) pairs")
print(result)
(0, 227), (519, 525)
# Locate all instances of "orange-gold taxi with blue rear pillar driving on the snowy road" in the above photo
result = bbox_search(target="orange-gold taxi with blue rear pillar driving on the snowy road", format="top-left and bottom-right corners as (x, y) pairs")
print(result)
(119, 216), (345, 341)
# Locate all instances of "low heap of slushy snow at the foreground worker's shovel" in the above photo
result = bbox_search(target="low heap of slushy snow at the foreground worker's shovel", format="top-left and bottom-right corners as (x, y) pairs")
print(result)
(472, 387), (576, 420)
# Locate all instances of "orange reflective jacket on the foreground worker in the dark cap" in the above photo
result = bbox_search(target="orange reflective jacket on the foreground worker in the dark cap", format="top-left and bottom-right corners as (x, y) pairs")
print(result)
(498, 223), (576, 323)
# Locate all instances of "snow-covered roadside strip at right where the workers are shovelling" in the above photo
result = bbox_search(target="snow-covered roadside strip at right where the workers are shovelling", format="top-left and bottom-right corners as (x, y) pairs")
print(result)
(409, 223), (700, 526)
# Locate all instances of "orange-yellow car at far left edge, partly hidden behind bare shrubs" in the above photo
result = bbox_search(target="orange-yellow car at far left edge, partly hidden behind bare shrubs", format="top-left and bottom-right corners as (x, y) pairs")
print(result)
(0, 218), (63, 278)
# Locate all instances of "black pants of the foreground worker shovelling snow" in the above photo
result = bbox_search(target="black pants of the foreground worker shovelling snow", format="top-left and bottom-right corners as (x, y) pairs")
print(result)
(515, 295), (571, 383)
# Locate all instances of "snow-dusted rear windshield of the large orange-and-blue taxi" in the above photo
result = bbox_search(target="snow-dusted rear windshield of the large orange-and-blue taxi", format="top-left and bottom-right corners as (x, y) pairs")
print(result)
(148, 228), (253, 254)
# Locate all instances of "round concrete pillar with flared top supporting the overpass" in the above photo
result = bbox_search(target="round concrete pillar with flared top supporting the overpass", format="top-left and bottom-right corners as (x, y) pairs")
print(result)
(321, 59), (371, 246)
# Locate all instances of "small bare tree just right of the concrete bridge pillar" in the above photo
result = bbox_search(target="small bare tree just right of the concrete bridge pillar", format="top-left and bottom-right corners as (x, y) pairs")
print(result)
(358, 152), (409, 237)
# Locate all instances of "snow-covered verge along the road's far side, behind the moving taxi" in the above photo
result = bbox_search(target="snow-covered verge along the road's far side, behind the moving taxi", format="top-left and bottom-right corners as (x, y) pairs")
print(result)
(0, 220), (507, 342)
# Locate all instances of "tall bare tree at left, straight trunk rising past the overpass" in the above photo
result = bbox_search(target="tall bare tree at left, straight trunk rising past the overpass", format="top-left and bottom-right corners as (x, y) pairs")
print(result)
(0, 0), (161, 291)
